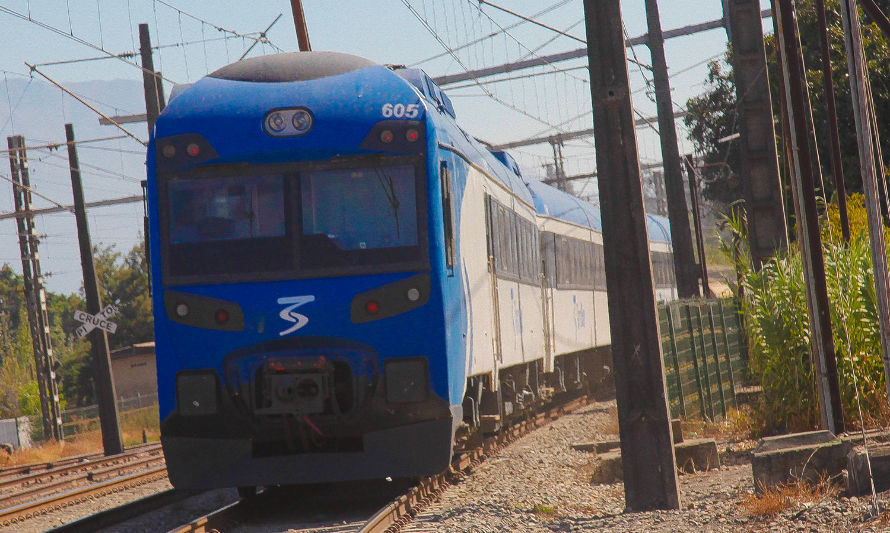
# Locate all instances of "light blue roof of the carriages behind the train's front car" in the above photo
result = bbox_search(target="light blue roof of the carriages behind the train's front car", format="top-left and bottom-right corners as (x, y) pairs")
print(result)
(528, 181), (671, 243)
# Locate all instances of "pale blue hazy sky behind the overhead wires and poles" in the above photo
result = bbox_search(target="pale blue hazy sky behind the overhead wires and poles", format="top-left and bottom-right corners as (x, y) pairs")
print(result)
(0, 0), (771, 293)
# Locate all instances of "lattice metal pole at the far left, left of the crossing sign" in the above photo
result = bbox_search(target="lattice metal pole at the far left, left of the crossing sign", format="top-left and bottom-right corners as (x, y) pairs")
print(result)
(6, 135), (64, 440)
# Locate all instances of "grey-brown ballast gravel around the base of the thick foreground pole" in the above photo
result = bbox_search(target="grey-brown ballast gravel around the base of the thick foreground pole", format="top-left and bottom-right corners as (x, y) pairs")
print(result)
(402, 401), (890, 533)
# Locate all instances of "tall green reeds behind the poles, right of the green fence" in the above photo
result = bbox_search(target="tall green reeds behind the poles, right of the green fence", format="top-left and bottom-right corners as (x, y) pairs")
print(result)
(727, 197), (890, 434)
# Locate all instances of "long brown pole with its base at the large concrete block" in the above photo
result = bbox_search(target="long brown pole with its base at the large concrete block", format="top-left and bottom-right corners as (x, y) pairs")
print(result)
(773, 0), (844, 435)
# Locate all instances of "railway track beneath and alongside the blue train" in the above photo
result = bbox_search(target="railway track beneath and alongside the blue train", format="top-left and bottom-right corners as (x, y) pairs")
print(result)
(164, 390), (590, 533)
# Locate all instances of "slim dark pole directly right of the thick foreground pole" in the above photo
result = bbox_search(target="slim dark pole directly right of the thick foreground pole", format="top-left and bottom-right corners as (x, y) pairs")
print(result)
(646, 0), (699, 298)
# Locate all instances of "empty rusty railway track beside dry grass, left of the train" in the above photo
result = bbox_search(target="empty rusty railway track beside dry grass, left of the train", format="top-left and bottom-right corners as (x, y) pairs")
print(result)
(0, 444), (167, 527)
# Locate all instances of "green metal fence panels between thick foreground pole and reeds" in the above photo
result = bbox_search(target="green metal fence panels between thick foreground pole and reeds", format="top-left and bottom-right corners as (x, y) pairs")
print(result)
(658, 299), (745, 420)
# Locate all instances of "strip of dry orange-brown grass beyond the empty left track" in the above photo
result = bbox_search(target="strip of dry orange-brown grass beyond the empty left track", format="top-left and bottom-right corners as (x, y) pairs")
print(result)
(0, 407), (160, 467)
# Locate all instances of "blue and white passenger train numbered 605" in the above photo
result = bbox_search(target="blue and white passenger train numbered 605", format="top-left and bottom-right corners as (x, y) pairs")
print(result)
(147, 52), (676, 494)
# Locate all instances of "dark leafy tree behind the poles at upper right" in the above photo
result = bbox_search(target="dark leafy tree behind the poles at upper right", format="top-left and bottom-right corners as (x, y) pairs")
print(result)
(684, 0), (890, 212)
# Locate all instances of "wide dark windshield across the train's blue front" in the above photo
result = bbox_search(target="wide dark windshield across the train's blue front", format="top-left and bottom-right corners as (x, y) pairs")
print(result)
(163, 159), (423, 281)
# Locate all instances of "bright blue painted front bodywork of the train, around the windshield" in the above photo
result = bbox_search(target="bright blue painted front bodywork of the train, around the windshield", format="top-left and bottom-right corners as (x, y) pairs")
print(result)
(147, 59), (465, 420)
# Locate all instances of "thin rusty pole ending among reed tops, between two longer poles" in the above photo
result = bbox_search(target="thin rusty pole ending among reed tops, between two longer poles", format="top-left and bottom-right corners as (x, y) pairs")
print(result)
(816, 0), (850, 242)
